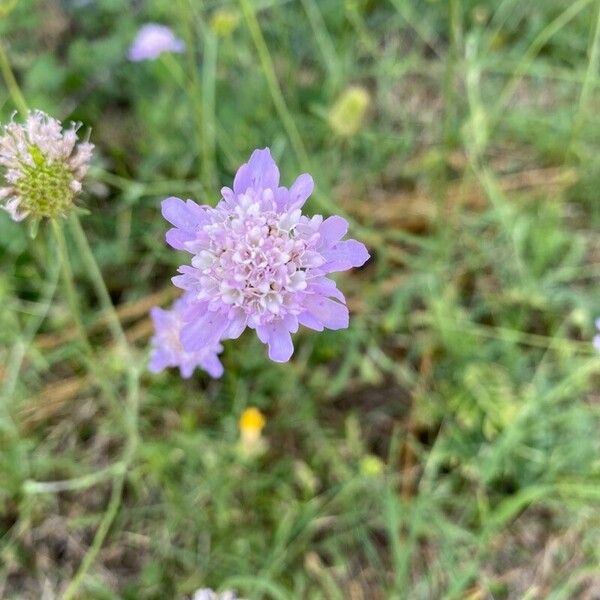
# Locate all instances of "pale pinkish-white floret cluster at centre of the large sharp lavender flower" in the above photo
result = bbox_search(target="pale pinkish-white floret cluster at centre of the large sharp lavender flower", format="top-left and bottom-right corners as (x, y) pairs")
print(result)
(191, 190), (323, 325)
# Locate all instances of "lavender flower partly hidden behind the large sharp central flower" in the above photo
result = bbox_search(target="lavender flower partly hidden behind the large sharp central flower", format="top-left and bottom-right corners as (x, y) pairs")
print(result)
(149, 294), (223, 379)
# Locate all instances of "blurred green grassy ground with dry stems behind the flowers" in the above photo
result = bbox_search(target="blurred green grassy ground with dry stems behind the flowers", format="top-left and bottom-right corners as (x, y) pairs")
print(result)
(0, 0), (600, 600)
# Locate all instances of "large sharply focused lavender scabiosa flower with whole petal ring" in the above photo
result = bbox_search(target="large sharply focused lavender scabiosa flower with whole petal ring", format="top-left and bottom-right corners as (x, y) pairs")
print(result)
(162, 148), (369, 362)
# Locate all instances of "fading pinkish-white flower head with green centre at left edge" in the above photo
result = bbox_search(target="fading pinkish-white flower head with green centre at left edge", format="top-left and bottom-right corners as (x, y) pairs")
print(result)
(0, 110), (94, 221)
